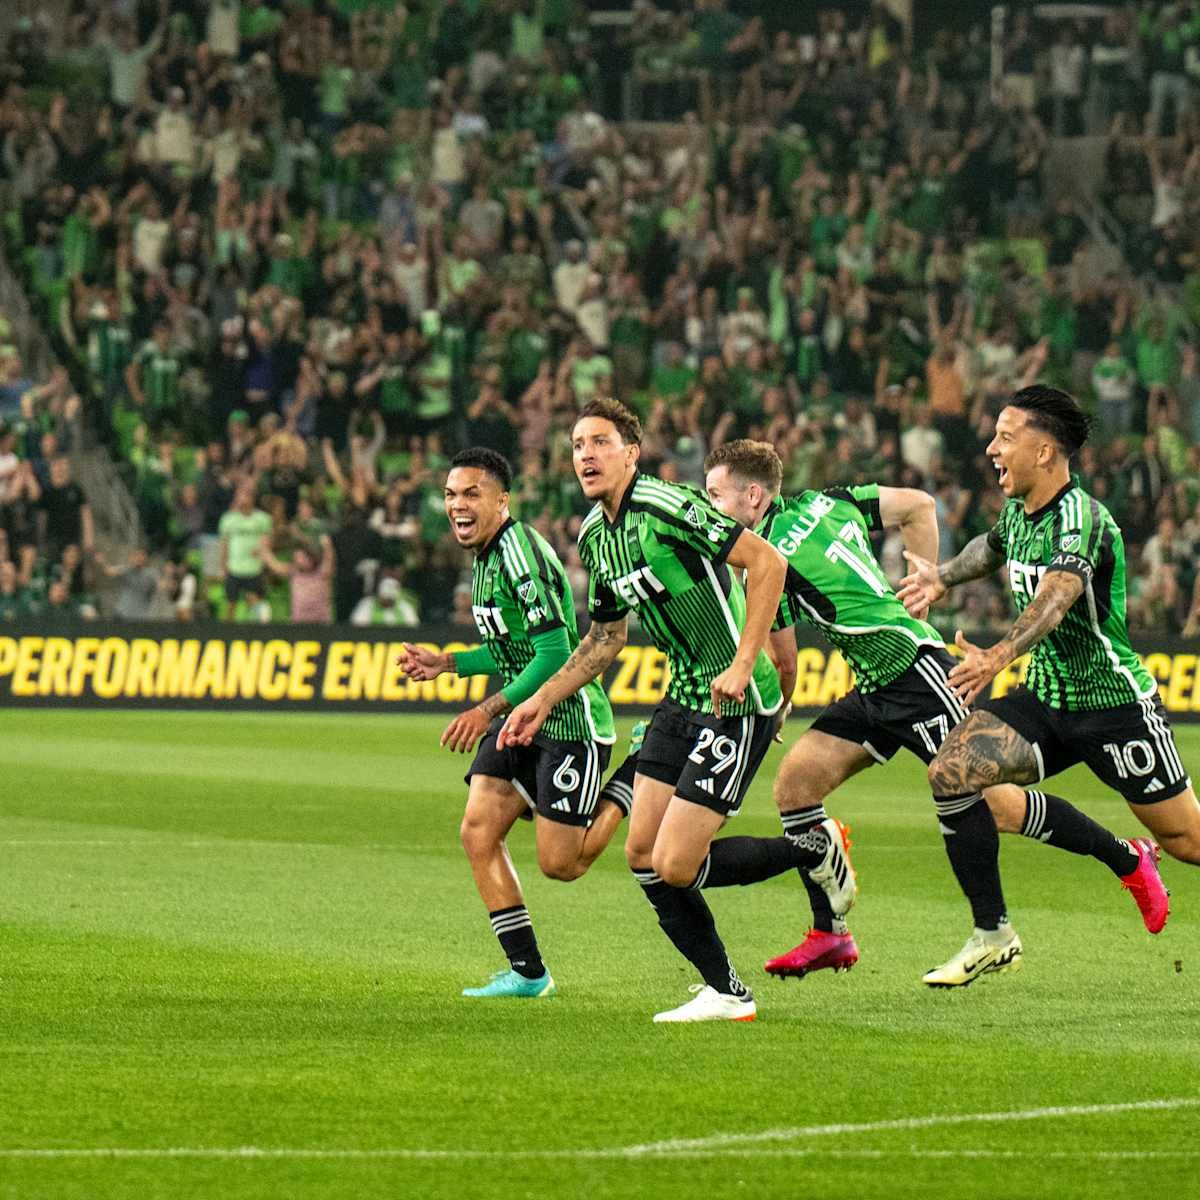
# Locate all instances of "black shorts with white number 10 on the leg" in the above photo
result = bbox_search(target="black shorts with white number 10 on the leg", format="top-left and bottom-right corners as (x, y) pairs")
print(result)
(977, 688), (1192, 804)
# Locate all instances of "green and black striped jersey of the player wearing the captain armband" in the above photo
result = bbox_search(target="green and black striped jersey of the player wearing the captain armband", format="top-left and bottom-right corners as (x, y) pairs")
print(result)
(988, 482), (1154, 712)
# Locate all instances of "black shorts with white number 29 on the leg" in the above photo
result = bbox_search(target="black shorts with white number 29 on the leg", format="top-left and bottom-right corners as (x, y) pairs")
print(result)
(637, 698), (775, 817)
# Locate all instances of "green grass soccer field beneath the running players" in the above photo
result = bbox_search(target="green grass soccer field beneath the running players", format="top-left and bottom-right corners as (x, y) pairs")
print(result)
(0, 712), (1200, 1200)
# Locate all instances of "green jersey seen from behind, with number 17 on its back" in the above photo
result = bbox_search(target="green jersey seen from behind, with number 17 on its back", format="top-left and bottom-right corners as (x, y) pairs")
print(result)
(758, 484), (944, 692)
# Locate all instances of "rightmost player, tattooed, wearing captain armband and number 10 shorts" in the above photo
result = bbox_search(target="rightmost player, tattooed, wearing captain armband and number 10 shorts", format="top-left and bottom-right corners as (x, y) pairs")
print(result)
(899, 385), (1200, 976)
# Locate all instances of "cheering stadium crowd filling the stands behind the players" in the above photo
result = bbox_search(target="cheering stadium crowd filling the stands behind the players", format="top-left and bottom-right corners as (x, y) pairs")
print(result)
(0, 0), (1200, 634)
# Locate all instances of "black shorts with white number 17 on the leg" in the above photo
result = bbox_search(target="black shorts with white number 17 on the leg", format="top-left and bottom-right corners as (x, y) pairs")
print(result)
(811, 647), (967, 763)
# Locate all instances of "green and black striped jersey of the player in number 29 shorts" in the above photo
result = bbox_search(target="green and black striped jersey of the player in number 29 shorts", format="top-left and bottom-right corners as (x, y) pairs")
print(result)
(580, 474), (784, 716)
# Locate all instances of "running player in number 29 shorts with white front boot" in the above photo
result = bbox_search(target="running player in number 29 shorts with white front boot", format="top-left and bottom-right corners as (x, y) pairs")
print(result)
(499, 400), (854, 1022)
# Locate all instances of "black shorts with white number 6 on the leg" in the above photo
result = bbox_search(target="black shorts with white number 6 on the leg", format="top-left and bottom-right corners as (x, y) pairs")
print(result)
(464, 718), (612, 826)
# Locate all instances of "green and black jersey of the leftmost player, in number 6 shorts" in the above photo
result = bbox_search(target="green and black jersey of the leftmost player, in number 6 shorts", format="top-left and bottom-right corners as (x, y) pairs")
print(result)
(470, 521), (613, 743)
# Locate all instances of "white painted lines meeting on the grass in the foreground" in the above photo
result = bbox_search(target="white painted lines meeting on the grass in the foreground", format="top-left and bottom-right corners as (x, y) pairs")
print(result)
(0, 1097), (1200, 1162)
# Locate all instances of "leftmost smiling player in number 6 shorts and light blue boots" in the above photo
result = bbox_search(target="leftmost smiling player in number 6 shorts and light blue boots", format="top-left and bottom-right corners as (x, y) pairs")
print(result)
(403, 448), (629, 998)
